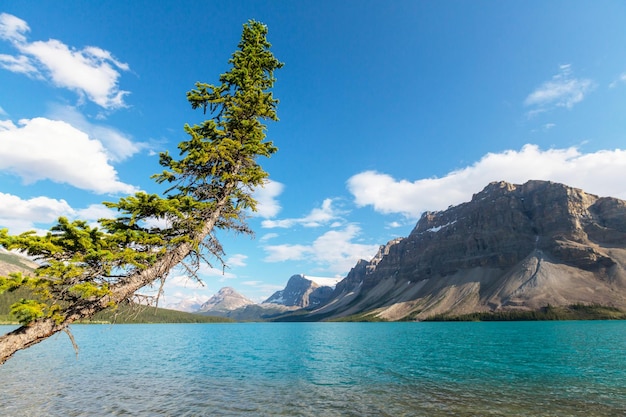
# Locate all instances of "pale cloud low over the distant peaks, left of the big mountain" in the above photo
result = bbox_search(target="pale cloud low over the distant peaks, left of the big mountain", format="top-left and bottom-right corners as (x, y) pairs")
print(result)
(264, 224), (378, 275)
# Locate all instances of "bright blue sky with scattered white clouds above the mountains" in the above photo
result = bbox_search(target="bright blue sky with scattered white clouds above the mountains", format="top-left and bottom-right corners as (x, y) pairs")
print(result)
(0, 0), (626, 306)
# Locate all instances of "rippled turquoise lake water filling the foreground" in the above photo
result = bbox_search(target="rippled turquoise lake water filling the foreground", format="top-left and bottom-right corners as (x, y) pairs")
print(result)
(0, 321), (626, 417)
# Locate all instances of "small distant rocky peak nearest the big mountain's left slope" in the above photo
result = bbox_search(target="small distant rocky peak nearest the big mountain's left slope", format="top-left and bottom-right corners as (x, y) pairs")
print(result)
(263, 274), (333, 308)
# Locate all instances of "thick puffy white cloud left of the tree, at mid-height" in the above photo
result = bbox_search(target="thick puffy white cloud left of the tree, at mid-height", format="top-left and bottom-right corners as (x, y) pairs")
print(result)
(0, 117), (137, 194)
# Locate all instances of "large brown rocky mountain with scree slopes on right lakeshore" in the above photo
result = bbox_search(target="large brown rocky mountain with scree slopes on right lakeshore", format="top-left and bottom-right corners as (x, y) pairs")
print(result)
(308, 181), (626, 320)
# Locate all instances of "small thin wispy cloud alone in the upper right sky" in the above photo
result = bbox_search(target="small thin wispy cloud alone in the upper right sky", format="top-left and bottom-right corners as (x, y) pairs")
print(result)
(524, 64), (594, 116)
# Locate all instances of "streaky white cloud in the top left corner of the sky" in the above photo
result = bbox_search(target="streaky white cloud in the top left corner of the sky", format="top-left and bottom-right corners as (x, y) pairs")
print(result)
(0, 13), (129, 109)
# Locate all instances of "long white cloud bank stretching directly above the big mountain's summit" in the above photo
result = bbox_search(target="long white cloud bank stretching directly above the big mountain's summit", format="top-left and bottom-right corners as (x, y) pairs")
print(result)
(347, 145), (626, 219)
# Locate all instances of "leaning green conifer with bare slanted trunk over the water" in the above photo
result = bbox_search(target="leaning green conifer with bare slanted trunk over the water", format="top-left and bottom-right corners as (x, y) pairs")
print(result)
(0, 21), (283, 364)
